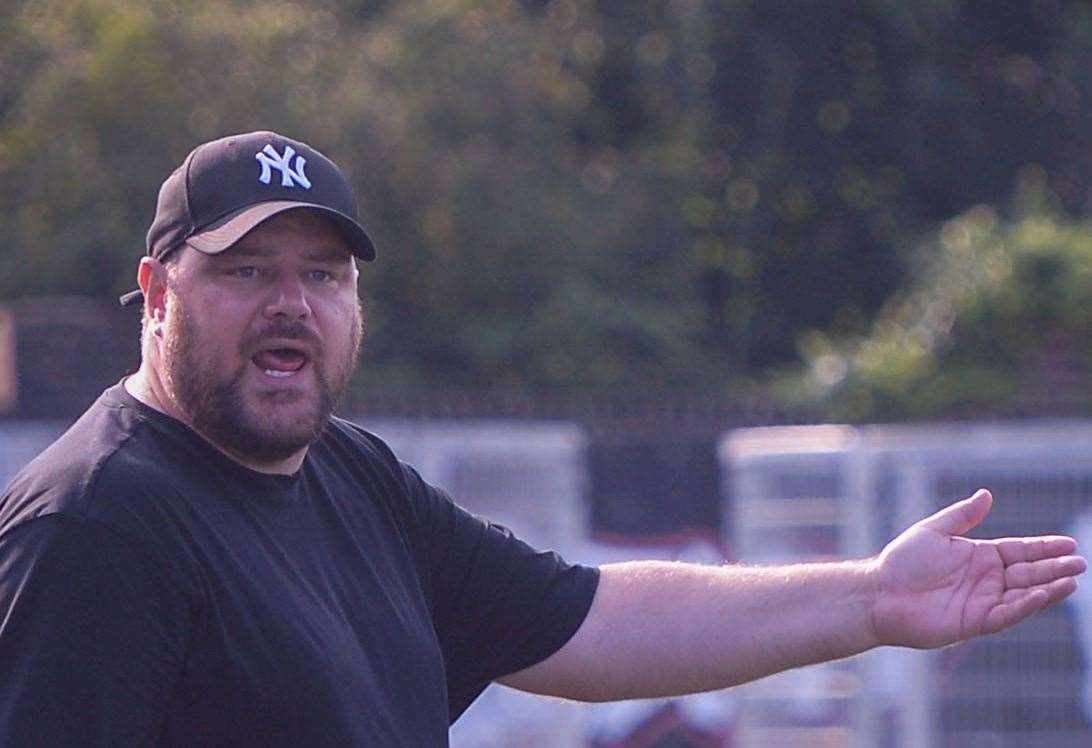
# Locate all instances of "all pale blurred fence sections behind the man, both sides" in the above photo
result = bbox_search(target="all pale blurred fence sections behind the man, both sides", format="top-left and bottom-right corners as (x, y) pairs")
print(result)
(0, 418), (1092, 748)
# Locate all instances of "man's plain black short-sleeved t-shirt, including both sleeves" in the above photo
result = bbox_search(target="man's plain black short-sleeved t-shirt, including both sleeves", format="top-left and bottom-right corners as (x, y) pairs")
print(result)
(0, 384), (597, 748)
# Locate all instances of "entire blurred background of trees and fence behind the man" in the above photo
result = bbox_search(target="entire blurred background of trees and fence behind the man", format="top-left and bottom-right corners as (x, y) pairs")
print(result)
(0, 0), (1092, 748)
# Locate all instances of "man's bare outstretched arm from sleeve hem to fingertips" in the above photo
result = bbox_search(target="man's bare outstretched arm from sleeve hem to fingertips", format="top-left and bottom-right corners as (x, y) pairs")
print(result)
(501, 490), (1085, 701)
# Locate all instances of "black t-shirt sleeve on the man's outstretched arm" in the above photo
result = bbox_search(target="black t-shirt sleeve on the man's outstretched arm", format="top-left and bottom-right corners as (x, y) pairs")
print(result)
(404, 467), (598, 722)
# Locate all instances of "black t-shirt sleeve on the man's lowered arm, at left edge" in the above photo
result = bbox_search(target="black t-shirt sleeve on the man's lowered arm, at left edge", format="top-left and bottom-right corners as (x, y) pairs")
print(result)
(0, 514), (191, 746)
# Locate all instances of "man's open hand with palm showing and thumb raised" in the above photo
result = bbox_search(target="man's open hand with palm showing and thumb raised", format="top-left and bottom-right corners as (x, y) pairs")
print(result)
(874, 491), (1084, 648)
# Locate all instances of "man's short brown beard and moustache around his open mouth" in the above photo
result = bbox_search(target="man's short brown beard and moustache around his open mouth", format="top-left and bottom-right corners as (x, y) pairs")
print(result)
(163, 295), (363, 464)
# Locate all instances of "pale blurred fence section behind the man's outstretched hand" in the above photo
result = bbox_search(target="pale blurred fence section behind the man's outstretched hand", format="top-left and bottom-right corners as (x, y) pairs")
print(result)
(721, 423), (1092, 748)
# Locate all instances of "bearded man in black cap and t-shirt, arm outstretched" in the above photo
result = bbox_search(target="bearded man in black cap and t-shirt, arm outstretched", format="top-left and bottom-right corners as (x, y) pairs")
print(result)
(0, 132), (1085, 747)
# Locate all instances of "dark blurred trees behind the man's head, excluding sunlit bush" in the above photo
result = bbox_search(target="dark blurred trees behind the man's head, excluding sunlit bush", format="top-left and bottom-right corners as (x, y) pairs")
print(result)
(6, 0), (1092, 402)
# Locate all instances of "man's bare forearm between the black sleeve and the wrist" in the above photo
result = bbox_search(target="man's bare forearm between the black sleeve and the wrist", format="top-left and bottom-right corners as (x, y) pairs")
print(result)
(507, 561), (875, 701)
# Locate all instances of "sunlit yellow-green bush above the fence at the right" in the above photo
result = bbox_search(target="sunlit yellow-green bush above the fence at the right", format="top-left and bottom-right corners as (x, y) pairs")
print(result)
(790, 200), (1092, 420)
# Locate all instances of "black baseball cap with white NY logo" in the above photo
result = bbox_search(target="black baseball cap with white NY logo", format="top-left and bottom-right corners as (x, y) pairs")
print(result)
(120, 130), (376, 306)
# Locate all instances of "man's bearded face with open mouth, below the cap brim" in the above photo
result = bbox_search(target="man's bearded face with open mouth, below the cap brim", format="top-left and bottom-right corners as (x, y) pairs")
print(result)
(161, 210), (361, 464)
